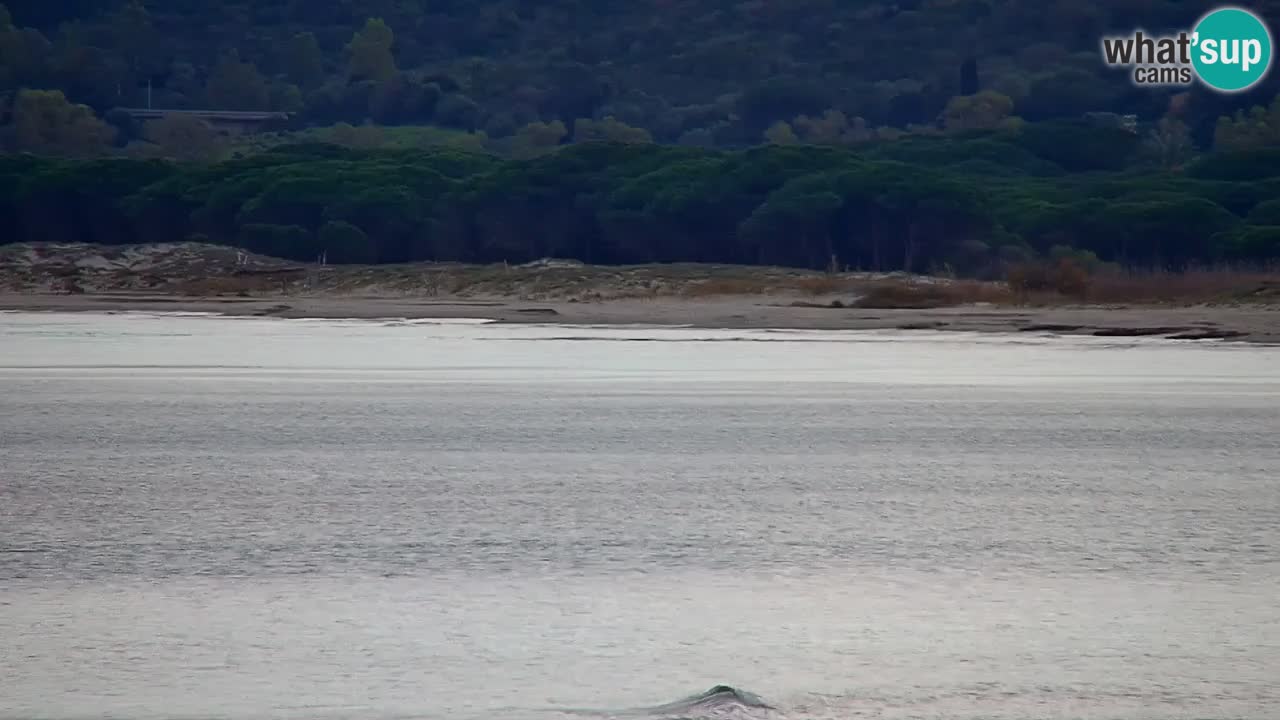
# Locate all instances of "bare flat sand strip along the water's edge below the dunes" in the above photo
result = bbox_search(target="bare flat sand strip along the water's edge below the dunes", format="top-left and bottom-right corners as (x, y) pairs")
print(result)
(0, 293), (1280, 345)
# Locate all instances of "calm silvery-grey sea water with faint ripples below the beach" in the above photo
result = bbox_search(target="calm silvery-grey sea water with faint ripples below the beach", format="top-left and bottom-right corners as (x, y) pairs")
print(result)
(0, 314), (1280, 720)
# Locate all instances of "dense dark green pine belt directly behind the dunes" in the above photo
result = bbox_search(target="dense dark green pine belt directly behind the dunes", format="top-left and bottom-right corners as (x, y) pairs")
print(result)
(0, 123), (1280, 270)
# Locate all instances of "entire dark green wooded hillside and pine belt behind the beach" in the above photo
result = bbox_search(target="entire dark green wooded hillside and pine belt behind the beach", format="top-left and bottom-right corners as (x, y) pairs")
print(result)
(0, 0), (1280, 270)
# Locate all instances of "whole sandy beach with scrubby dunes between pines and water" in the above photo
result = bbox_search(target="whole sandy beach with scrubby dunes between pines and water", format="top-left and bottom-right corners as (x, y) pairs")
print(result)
(0, 243), (1280, 345)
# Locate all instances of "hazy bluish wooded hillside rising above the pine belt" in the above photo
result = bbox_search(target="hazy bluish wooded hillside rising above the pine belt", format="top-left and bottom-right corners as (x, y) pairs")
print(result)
(0, 0), (1280, 155)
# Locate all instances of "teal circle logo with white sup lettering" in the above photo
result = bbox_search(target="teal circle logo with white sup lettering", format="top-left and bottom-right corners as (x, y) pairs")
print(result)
(1192, 8), (1271, 92)
